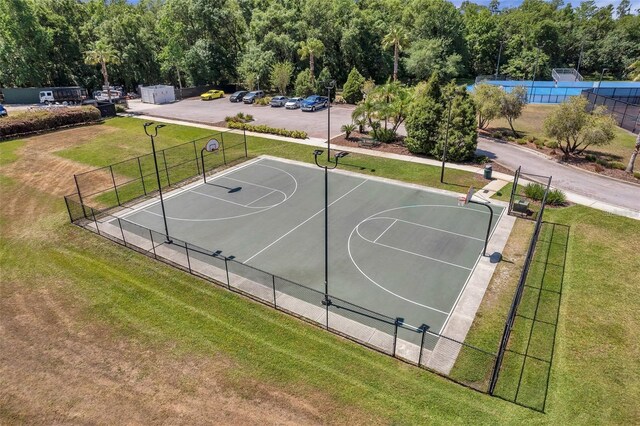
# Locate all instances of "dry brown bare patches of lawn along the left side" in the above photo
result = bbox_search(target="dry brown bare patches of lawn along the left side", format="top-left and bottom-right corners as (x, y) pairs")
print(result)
(0, 126), (340, 425)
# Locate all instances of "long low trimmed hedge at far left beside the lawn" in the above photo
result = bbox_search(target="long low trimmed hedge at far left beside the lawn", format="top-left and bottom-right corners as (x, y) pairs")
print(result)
(0, 106), (100, 139)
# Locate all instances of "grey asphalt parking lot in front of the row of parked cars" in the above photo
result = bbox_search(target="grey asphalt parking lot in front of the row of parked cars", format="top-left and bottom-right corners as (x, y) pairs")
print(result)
(129, 94), (354, 139)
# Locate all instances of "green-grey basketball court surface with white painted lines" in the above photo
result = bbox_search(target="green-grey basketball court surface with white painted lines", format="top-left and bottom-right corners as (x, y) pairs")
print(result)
(115, 157), (504, 346)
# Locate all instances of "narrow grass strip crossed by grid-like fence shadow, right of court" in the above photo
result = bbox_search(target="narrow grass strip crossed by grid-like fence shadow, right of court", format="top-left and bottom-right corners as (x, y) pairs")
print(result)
(494, 222), (570, 412)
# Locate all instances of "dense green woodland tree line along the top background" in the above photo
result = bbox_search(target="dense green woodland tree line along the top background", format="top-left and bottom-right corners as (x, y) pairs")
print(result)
(0, 0), (640, 90)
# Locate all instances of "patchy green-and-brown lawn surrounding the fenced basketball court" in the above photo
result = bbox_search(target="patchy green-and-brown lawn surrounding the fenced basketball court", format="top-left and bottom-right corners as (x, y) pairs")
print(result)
(0, 119), (640, 424)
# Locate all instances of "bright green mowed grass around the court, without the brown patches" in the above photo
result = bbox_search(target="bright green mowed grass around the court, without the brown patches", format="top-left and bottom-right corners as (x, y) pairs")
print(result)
(0, 116), (640, 424)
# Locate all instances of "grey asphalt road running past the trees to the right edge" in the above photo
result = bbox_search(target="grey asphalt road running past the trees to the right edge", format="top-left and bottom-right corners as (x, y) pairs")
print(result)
(476, 138), (640, 211)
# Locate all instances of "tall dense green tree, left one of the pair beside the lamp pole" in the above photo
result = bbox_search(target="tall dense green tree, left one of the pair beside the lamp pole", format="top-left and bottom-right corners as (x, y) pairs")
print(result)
(405, 74), (444, 154)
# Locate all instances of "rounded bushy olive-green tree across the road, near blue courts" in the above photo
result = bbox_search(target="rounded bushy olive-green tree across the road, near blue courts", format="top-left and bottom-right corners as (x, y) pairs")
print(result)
(544, 96), (616, 159)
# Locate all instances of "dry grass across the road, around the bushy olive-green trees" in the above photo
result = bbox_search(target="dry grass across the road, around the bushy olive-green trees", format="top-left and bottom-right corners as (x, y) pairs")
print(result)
(488, 104), (635, 165)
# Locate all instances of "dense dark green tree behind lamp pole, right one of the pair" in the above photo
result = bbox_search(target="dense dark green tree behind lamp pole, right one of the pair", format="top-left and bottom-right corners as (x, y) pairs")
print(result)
(431, 83), (478, 161)
